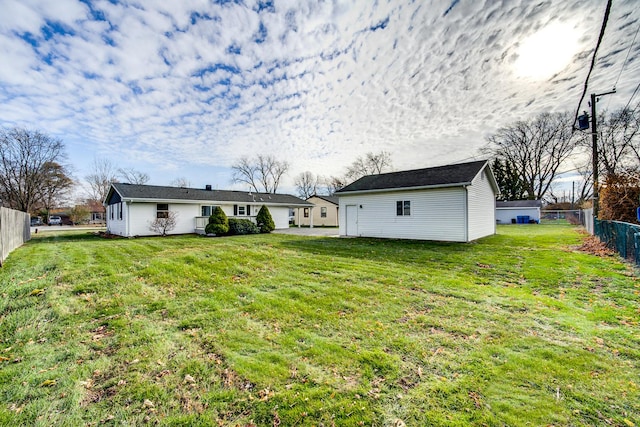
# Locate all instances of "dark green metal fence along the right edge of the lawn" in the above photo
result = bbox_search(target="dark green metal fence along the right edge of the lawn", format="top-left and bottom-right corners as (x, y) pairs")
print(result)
(594, 219), (640, 265)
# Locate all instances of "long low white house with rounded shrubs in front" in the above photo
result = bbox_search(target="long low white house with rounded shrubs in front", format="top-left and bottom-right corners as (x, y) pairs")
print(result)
(104, 183), (313, 237)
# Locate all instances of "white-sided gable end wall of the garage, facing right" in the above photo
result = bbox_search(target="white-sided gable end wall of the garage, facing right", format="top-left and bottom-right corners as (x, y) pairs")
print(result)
(467, 169), (496, 241)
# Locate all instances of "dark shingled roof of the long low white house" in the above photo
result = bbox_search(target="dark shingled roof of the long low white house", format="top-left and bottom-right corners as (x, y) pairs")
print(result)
(105, 182), (313, 206)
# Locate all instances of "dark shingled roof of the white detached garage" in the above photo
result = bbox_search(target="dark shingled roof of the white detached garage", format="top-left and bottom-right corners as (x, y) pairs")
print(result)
(336, 160), (497, 194)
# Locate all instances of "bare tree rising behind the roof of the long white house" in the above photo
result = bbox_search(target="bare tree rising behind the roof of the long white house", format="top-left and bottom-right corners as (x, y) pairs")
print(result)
(231, 154), (289, 193)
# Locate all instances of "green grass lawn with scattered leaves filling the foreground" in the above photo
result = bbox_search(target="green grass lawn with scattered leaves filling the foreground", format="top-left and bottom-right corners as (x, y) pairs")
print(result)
(0, 225), (640, 426)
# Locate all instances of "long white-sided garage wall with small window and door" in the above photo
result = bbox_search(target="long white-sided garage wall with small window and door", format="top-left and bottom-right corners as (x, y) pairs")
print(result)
(338, 187), (466, 242)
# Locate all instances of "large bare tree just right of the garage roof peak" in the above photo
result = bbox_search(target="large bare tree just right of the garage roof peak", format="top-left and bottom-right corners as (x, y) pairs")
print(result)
(484, 113), (578, 200)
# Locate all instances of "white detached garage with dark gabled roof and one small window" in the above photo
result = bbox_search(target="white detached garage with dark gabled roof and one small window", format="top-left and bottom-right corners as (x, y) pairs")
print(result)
(336, 161), (498, 242)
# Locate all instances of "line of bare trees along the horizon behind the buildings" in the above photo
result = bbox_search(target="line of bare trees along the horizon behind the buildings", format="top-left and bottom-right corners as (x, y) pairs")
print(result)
(0, 104), (640, 224)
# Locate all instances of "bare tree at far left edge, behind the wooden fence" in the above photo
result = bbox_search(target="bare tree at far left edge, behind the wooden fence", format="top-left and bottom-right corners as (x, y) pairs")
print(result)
(0, 128), (65, 212)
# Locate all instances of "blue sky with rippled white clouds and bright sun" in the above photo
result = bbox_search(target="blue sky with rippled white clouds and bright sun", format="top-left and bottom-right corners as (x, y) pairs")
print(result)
(0, 0), (640, 197)
